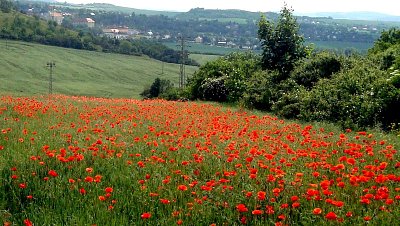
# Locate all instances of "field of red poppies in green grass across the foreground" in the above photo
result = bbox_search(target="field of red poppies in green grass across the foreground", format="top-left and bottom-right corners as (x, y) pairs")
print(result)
(0, 95), (400, 225)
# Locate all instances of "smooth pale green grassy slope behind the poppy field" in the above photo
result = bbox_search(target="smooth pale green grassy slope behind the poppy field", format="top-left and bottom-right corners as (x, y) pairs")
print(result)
(0, 40), (196, 98)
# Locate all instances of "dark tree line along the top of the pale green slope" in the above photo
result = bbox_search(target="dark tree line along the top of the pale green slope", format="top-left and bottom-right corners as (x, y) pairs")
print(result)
(0, 0), (198, 66)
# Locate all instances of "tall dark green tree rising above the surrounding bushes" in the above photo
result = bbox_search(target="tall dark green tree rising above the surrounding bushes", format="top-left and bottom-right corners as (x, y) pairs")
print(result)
(258, 5), (307, 80)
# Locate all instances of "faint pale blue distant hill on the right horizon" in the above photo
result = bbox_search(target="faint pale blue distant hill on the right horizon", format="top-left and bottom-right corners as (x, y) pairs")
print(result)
(300, 12), (400, 22)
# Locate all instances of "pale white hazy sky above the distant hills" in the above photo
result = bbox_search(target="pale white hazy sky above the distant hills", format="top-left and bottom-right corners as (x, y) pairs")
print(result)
(66, 0), (400, 16)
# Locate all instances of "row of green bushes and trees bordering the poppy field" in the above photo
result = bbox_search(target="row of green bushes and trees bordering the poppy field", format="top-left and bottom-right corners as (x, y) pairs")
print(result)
(150, 6), (400, 130)
